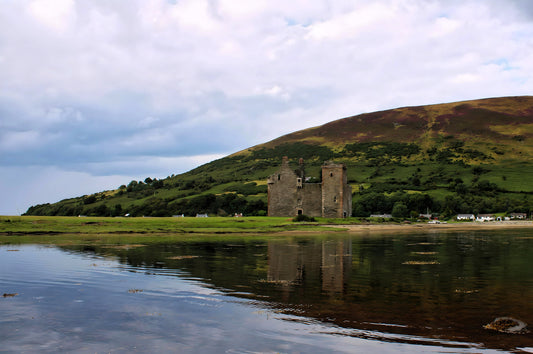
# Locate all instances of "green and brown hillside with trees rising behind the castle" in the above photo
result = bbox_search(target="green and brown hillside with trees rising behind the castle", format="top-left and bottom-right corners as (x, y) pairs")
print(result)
(26, 96), (533, 216)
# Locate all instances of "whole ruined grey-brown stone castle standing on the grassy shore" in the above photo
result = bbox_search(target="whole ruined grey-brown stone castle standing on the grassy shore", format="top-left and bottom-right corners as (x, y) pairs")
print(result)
(268, 156), (352, 218)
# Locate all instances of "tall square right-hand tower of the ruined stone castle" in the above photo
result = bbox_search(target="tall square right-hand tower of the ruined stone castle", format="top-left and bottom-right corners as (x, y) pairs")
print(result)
(322, 161), (352, 218)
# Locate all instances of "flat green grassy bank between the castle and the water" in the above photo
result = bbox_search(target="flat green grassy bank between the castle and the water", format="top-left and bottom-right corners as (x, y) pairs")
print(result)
(0, 216), (533, 244)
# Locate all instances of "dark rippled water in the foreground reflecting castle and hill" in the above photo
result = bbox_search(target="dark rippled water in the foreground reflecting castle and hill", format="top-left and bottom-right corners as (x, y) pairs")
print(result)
(0, 231), (533, 353)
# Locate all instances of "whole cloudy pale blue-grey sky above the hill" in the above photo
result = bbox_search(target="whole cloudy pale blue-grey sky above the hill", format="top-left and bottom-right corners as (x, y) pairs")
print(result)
(0, 0), (533, 215)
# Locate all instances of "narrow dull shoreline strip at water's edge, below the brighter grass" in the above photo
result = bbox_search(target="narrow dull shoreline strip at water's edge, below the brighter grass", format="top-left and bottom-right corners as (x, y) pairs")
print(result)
(0, 221), (533, 246)
